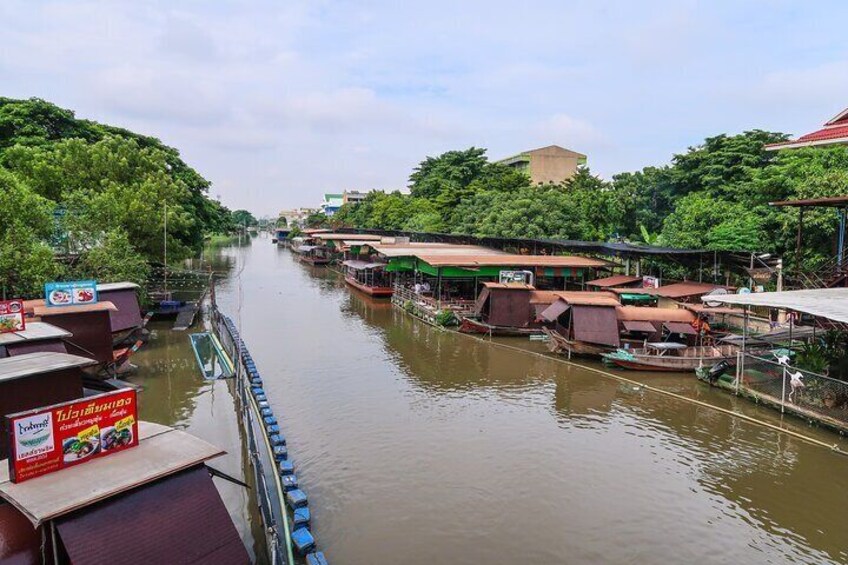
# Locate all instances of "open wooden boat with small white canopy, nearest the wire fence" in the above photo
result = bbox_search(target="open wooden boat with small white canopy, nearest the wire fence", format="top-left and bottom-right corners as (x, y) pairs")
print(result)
(603, 342), (738, 372)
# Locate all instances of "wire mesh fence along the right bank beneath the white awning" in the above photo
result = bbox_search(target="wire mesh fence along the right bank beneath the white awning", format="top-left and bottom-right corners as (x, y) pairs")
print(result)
(736, 354), (848, 429)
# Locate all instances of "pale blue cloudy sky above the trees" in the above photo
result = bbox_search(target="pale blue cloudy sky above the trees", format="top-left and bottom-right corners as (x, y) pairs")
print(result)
(0, 0), (848, 216)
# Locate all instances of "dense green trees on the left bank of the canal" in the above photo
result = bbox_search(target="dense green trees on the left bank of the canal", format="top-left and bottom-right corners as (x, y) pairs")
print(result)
(0, 98), (233, 296)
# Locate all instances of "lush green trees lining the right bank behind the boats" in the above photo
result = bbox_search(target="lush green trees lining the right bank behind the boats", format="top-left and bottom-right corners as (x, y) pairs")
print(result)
(333, 130), (848, 274)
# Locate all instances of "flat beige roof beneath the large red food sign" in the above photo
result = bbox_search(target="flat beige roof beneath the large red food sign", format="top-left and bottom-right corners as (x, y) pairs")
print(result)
(0, 420), (225, 527)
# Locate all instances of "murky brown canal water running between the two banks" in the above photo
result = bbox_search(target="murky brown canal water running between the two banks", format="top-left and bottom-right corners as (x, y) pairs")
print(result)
(143, 238), (848, 565)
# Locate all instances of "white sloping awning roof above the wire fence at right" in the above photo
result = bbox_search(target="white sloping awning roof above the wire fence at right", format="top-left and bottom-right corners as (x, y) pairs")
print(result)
(702, 288), (848, 323)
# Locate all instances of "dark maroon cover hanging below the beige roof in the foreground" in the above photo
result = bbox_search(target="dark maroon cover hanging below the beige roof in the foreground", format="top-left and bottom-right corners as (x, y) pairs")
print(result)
(56, 465), (249, 565)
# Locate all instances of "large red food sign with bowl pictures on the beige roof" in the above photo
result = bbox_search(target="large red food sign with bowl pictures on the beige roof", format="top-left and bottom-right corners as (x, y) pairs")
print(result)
(6, 388), (138, 483)
